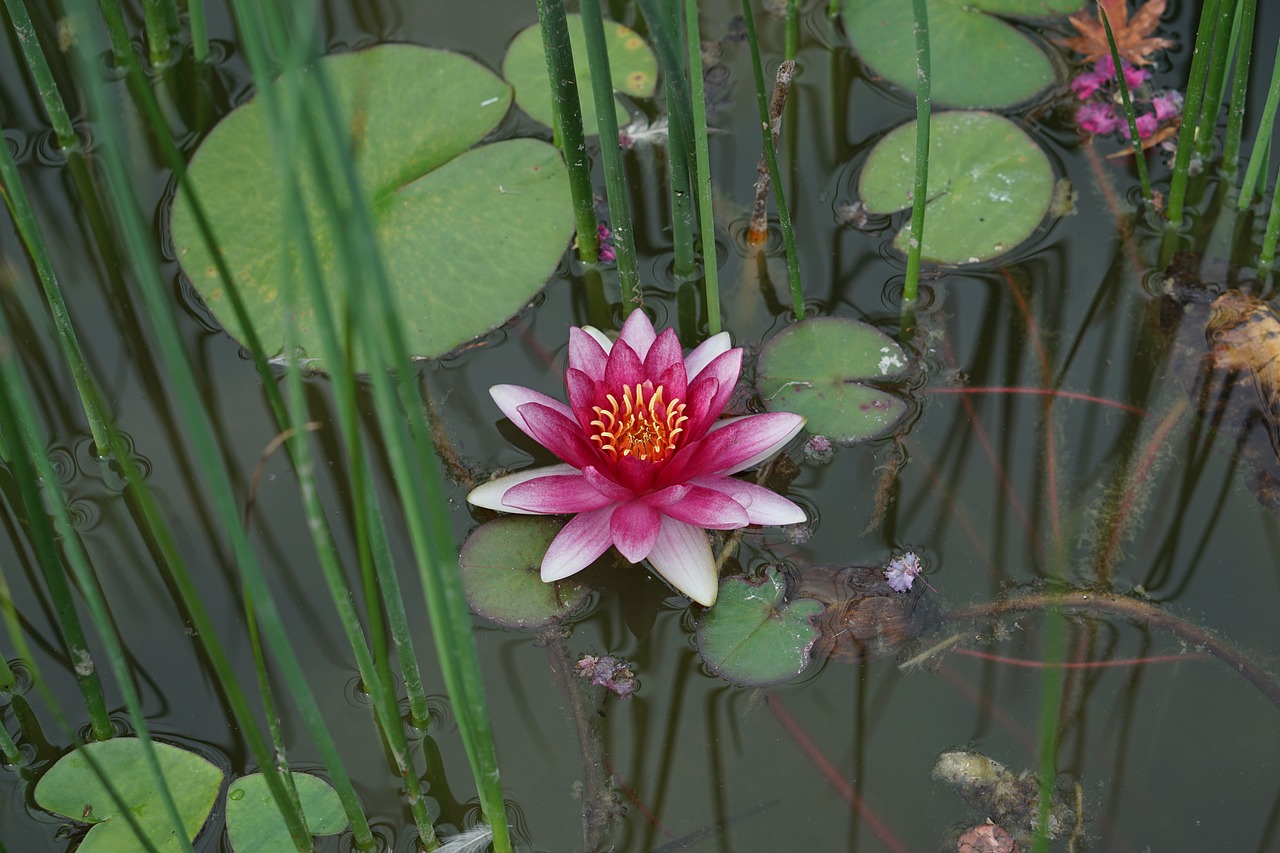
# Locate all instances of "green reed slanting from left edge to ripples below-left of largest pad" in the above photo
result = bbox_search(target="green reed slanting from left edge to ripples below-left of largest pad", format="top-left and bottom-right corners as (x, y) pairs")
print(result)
(0, 126), (109, 455)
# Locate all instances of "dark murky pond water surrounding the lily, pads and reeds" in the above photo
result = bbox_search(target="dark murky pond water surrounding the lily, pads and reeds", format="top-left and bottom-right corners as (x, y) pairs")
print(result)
(0, 1), (1280, 852)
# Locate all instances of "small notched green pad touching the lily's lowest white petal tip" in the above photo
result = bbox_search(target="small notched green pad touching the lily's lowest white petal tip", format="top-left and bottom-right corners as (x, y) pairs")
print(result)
(698, 569), (823, 685)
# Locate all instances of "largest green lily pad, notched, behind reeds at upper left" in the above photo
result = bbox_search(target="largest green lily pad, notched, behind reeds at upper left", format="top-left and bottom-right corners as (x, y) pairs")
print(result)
(173, 45), (573, 366)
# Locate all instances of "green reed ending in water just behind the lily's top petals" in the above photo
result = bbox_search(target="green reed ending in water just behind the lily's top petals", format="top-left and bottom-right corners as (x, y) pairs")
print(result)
(579, 0), (644, 316)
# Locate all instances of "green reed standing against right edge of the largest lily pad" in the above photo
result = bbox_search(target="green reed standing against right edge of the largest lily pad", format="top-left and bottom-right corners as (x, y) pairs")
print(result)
(538, 0), (600, 264)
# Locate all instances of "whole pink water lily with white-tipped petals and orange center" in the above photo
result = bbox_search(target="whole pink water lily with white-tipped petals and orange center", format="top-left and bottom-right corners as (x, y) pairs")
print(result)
(467, 311), (805, 607)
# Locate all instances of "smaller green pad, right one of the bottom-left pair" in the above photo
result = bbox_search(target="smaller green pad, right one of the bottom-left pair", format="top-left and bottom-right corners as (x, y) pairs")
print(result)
(227, 774), (347, 853)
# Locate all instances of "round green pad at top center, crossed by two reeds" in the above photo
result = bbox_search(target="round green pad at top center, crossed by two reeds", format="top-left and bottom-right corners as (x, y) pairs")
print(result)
(502, 15), (658, 136)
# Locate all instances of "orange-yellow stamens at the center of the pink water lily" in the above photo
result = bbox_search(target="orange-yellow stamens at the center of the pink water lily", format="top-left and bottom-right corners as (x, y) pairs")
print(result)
(591, 382), (689, 462)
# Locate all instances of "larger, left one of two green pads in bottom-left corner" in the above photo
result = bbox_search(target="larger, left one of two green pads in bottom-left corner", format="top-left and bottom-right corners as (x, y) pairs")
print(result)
(36, 738), (223, 853)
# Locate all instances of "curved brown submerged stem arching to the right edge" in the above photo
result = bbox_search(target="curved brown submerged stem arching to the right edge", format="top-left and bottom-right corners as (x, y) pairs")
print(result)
(946, 588), (1280, 708)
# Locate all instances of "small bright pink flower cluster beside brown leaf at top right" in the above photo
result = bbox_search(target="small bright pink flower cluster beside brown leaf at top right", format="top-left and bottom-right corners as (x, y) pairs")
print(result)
(1071, 56), (1183, 140)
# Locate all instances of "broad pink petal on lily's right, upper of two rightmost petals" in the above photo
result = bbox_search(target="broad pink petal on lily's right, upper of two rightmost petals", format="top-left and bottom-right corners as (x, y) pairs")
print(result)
(658, 411), (804, 485)
